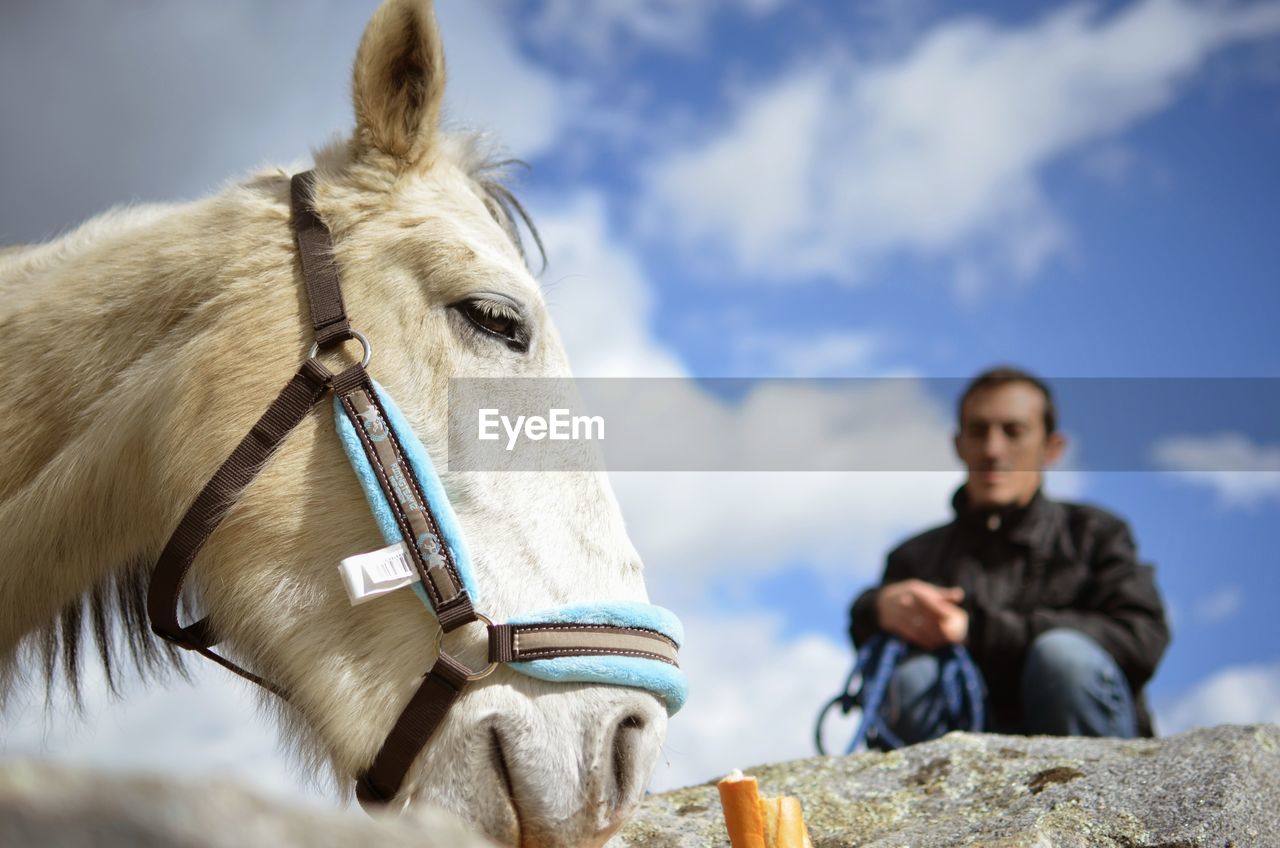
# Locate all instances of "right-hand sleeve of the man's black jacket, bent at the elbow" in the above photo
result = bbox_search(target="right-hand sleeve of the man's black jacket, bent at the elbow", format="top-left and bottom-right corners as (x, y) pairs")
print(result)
(969, 521), (1169, 689)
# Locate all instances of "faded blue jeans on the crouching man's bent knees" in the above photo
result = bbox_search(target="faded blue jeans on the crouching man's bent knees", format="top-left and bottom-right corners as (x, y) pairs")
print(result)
(882, 628), (1138, 744)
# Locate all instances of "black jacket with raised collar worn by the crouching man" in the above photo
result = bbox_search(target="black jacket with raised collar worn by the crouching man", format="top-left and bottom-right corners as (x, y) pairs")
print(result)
(849, 487), (1169, 735)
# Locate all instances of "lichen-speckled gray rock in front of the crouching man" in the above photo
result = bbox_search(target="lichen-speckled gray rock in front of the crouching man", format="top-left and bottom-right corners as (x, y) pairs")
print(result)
(611, 725), (1280, 848)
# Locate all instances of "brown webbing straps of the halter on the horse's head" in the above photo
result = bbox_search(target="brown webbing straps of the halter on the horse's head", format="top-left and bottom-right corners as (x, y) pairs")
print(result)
(147, 172), (677, 806)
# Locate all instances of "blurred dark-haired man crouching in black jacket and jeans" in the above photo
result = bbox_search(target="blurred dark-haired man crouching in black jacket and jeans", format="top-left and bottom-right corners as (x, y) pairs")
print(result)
(850, 368), (1169, 744)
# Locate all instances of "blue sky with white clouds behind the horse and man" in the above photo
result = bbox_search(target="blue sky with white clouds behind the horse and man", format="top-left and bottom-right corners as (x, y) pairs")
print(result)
(0, 0), (1280, 792)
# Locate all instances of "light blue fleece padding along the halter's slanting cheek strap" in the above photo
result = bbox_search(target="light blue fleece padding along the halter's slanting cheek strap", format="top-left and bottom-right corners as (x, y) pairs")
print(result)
(333, 380), (480, 610)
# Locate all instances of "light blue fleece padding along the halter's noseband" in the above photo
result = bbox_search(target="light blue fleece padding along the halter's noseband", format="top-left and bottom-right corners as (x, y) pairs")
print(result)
(507, 601), (689, 715)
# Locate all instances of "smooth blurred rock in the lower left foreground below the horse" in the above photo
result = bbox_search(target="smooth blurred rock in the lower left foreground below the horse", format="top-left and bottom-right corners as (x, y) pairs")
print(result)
(0, 760), (493, 848)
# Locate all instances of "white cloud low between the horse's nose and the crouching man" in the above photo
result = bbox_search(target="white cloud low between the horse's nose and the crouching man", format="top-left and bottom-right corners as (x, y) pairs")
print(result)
(654, 614), (852, 790)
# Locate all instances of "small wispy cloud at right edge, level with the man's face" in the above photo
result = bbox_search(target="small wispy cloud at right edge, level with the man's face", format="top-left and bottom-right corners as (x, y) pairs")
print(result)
(1152, 433), (1280, 506)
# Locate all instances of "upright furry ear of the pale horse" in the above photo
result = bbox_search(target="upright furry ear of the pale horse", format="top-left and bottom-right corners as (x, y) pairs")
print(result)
(353, 0), (444, 164)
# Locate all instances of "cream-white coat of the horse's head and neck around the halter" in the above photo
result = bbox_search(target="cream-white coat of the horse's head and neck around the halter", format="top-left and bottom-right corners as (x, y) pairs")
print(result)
(0, 0), (667, 845)
